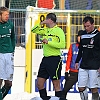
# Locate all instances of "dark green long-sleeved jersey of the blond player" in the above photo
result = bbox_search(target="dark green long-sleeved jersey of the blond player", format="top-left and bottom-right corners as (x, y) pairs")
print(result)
(0, 21), (15, 53)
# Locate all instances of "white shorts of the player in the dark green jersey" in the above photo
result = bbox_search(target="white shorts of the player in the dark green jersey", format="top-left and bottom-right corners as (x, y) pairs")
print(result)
(0, 53), (14, 81)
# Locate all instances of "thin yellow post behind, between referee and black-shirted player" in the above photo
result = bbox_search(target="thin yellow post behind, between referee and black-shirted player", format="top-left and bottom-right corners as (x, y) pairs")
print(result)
(66, 13), (71, 49)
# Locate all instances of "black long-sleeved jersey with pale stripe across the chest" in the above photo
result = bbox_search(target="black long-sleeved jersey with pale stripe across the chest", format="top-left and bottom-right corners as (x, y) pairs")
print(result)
(76, 29), (100, 70)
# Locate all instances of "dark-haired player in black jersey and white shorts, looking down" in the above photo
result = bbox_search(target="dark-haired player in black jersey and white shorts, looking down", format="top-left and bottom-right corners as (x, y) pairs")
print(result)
(75, 16), (100, 100)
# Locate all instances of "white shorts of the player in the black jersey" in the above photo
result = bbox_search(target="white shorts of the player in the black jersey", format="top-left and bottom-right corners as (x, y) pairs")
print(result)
(78, 68), (100, 88)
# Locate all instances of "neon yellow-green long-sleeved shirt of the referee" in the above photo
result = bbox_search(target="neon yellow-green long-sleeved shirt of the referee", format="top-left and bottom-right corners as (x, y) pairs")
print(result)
(32, 24), (65, 57)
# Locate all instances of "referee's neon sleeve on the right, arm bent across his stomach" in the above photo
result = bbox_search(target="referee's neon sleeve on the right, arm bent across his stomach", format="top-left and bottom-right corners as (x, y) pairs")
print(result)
(48, 29), (65, 48)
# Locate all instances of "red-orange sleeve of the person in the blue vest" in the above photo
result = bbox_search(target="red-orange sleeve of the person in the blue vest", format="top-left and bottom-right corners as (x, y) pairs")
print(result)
(65, 45), (72, 72)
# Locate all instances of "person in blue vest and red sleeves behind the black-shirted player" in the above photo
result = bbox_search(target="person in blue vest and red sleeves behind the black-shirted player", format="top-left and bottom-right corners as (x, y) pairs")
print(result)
(62, 30), (83, 98)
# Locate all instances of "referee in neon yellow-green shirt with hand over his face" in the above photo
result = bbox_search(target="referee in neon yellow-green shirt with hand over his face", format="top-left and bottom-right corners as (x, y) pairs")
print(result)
(32, 13), (65, 100)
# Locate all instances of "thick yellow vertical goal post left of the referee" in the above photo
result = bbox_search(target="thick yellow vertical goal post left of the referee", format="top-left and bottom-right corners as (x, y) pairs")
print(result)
(25, 12), (32, 93)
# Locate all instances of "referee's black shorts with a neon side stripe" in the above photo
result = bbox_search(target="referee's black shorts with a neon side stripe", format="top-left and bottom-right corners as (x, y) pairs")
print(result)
(37, 56), (62, 80)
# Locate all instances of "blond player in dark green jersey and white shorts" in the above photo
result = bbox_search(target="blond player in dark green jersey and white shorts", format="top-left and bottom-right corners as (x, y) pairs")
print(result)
(0, 7), (15, 100)
